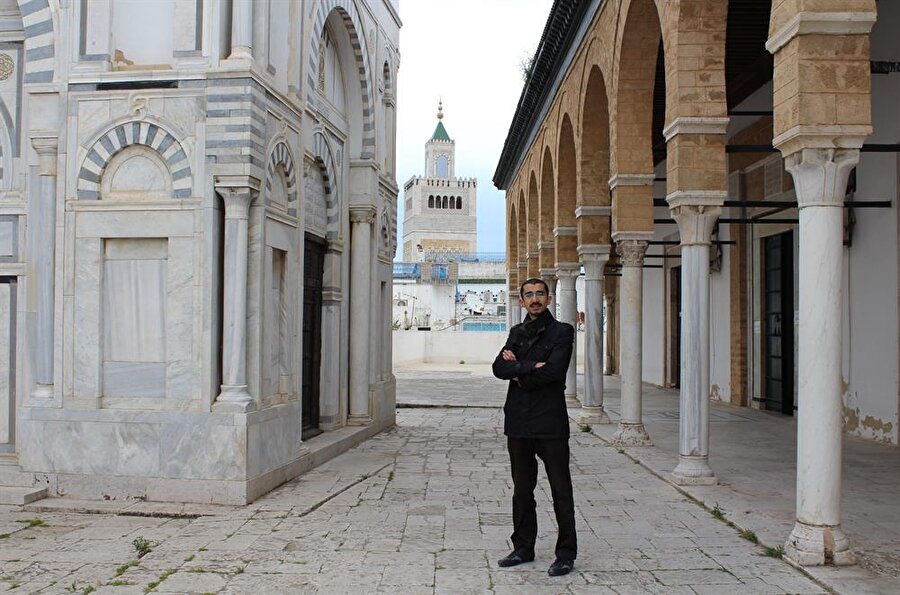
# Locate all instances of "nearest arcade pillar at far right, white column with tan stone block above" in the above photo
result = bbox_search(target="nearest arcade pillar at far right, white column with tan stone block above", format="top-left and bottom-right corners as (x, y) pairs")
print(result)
(766, 0), (877, 566)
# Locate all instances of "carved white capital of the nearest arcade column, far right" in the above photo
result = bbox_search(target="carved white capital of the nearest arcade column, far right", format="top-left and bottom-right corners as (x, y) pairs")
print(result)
(784, 149), (859, 209)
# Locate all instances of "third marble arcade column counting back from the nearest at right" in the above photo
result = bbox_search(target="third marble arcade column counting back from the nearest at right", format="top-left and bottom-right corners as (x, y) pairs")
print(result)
(613, 234), (652, 446)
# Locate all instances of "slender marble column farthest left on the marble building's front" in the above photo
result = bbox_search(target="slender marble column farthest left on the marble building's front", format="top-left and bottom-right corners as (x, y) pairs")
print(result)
(31, 136), (59, 399)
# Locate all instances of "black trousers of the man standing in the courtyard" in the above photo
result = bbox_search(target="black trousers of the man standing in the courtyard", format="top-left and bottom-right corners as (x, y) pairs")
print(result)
(507, 437), (578, 560)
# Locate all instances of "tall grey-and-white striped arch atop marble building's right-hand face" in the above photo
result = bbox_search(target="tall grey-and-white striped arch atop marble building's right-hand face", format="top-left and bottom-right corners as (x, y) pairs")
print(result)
(306, 0), (375, 159)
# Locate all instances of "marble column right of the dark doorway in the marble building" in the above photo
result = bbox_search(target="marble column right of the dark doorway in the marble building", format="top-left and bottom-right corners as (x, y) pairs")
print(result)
(347, 205), (375, 426)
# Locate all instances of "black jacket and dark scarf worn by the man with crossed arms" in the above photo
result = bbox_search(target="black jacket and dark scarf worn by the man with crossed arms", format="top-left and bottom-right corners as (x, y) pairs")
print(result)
(493, 310), (575, 438)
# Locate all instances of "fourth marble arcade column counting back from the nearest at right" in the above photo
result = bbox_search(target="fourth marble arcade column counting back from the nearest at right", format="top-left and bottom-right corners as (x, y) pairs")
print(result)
(578, 246), (609, 425)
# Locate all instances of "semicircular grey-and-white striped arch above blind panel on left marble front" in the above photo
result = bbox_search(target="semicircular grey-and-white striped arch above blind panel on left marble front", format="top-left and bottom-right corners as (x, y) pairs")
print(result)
(76, 122), (192, 200)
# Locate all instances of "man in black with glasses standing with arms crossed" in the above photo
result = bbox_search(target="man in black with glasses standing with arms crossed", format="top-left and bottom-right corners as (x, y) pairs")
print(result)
(493, 278), (578, 576)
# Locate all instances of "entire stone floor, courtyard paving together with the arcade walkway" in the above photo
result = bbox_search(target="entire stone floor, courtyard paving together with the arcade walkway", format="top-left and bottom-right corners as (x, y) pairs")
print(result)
(0, 365), (900, 594)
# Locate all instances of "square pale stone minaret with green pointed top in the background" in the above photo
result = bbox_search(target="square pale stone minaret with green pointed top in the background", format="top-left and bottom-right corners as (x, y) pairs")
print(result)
(403, 101), (478, 262)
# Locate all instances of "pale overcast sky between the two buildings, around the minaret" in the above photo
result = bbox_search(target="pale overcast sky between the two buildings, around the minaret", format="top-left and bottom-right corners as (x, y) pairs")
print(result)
(397, 0), (552, 255)
